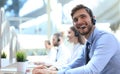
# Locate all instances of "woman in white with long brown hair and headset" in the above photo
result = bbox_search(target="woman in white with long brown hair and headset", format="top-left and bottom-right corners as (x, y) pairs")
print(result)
(67, 26), (85, 63)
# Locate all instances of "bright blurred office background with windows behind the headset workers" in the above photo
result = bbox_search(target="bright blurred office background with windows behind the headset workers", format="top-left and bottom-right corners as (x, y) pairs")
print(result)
(0, 0), (120, 67)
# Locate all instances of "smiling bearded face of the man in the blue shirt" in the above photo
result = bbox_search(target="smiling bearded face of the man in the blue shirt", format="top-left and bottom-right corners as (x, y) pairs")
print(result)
(72, 9), (93, 35)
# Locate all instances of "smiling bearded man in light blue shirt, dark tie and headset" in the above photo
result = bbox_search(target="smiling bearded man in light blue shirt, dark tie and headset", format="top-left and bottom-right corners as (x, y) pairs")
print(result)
(34, 4), (120, 74)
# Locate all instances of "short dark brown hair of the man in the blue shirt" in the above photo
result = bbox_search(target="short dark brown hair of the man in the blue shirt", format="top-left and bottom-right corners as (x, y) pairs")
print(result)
(71, 4), (96, 25)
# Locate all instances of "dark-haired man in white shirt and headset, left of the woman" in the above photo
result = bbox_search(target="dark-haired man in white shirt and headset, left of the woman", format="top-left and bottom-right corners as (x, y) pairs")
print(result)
(34, 32), (70, 73)
